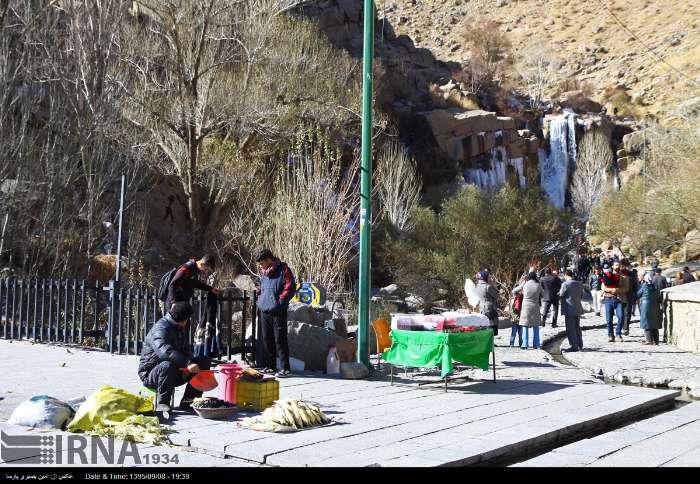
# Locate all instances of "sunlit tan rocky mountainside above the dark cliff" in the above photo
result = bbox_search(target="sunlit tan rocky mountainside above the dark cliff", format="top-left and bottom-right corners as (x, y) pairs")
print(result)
(377, 0), (700, 121)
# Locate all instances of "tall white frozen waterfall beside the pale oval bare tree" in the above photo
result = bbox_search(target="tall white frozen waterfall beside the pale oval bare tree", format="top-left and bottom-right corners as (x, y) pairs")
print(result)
(538, 113), (576, 208)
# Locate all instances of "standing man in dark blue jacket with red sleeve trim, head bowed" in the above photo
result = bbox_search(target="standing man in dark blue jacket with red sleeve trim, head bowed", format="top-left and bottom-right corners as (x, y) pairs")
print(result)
(255, 249), (296, 378)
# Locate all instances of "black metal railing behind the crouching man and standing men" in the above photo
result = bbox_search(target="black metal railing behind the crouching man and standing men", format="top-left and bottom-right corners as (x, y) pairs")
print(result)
(0, 278), (257, 361)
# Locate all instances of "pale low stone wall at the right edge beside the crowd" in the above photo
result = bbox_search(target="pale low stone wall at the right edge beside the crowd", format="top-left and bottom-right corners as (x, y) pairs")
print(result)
(663, 282), (700, 353)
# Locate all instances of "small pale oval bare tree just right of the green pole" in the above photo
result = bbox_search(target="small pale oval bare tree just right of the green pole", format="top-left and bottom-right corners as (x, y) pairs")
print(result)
(377, 141), (422, 231)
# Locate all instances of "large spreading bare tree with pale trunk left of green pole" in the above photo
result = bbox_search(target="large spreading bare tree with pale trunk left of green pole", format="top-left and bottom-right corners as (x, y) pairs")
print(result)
(112, 0), (359, 253)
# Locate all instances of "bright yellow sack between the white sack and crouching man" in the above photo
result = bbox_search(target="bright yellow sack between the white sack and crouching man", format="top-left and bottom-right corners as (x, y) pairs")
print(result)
(68, 385), (153, 432)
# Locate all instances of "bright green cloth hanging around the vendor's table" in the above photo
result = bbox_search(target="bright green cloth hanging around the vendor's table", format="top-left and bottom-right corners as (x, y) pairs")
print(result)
(382, 329), (493, 377)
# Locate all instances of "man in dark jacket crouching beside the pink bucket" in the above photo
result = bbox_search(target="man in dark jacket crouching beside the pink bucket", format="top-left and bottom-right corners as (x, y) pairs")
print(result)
(139, 302), (211, 420)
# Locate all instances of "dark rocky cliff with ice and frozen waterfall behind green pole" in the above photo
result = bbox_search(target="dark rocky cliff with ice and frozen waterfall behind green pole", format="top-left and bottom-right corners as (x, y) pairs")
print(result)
(298, 0), (634, 201)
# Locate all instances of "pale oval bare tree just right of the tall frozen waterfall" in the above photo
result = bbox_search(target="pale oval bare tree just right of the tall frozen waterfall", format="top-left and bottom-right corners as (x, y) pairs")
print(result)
(571, 128), (613, 227)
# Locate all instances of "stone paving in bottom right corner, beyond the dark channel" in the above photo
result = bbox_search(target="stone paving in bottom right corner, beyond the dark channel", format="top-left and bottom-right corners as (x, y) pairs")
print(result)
(515, 402), (700, 467)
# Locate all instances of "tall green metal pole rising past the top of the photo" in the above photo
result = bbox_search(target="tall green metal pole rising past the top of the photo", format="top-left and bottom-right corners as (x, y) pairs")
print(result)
(357, 0), (374, 367)
